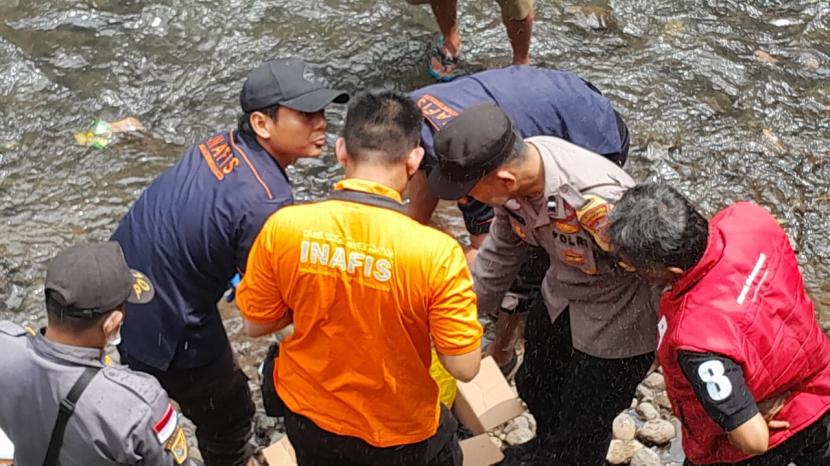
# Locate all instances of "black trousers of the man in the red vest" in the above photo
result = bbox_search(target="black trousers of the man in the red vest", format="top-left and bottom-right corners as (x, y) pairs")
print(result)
(683, 413), (830, 466)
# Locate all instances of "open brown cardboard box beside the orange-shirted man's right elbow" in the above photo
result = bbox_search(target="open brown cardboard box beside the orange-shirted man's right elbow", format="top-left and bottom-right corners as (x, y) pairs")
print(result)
(453, 356), (524, 435)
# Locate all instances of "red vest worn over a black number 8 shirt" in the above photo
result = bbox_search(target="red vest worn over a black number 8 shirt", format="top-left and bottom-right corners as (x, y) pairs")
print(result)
(657, 203), (830, 464)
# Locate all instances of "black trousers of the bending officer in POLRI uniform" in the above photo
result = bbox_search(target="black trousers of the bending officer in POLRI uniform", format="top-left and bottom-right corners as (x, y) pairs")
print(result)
(516, 300), (654, 466)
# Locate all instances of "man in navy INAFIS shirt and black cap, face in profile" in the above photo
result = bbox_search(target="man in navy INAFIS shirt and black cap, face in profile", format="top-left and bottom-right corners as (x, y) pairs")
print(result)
(112, 59), (348, 466)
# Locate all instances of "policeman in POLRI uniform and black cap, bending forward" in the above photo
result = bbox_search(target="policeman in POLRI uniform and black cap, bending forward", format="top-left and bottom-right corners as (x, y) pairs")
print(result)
(428, 104), (657, 466)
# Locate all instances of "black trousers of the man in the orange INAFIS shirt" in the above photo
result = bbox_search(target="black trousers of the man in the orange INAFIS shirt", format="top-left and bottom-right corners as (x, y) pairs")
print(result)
(285, 405), (463, 466)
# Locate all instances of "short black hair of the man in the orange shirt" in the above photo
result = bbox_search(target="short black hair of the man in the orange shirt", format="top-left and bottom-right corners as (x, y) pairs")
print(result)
(343, 91), (424, 164)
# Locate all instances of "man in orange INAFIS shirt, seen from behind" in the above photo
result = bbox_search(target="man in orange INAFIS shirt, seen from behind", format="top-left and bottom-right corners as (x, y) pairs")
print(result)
(237, 92), (482, 466)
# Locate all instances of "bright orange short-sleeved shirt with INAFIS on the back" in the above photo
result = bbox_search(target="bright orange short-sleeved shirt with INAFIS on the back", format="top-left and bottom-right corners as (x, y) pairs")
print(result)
(237, 179), (482, 447)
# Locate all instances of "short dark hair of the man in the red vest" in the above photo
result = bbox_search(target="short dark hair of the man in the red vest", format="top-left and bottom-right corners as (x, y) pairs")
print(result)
(608, 183), (709, 270)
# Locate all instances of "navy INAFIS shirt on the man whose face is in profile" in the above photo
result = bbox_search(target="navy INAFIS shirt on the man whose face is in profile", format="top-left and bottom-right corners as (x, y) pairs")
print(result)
(112, 130), (293, 370)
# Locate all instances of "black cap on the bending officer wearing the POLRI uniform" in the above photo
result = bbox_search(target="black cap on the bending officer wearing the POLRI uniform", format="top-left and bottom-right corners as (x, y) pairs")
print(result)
(427, 103), (524, 200)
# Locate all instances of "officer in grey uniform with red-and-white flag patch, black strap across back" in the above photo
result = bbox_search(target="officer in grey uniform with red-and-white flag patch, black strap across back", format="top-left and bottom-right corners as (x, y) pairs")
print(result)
(0, 242), (194, 466)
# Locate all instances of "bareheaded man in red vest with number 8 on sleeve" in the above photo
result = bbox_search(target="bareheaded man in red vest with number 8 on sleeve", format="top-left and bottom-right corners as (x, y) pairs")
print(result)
(608, 183), (830, 466)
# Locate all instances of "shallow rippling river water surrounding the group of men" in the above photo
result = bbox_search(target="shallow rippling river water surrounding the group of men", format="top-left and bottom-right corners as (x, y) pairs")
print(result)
(0, 0), (830, 460)
